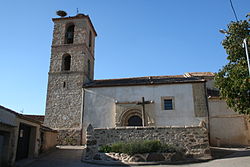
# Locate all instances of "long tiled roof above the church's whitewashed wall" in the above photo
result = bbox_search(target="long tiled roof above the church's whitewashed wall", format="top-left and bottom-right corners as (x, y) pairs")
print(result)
(83, 75), (205, 88)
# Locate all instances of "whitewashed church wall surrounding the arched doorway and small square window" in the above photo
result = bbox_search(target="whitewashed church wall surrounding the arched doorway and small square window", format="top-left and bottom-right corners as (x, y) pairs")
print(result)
(83, 84), (204, 128)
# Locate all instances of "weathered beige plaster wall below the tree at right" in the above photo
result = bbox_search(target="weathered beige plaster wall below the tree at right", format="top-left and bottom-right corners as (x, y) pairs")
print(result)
(208, 98), (250, 146)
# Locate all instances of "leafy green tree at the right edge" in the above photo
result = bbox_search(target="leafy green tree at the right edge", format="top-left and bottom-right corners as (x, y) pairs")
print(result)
(215, 20), (250, 115)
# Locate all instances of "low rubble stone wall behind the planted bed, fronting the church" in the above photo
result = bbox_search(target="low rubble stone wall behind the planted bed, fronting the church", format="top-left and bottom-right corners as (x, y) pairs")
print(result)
(85, 125), (210, 160)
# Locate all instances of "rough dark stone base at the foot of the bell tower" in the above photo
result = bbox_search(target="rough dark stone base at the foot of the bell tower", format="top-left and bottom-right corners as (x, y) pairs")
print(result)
(57, 128), (81, 146)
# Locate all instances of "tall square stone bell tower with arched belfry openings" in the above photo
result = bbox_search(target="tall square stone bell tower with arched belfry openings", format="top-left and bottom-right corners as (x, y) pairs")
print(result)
(44, 14), (97, 144)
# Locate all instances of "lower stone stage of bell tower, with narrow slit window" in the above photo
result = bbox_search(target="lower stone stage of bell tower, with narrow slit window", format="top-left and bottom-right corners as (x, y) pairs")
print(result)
(44, 73), (83, 128)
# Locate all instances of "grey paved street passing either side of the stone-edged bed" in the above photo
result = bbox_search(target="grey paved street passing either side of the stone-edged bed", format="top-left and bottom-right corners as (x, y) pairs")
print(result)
(23, 147), (250, 167)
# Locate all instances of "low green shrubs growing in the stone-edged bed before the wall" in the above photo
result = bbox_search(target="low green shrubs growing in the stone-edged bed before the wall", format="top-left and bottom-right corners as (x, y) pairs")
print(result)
(99, 140), (179, 155)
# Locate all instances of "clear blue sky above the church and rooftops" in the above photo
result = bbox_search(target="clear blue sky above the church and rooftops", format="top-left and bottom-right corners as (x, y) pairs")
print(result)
(0, 0), (250, 114)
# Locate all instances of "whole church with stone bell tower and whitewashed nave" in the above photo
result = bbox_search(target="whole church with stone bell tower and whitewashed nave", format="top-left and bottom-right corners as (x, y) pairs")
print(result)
(44, 14), (250, 145)
